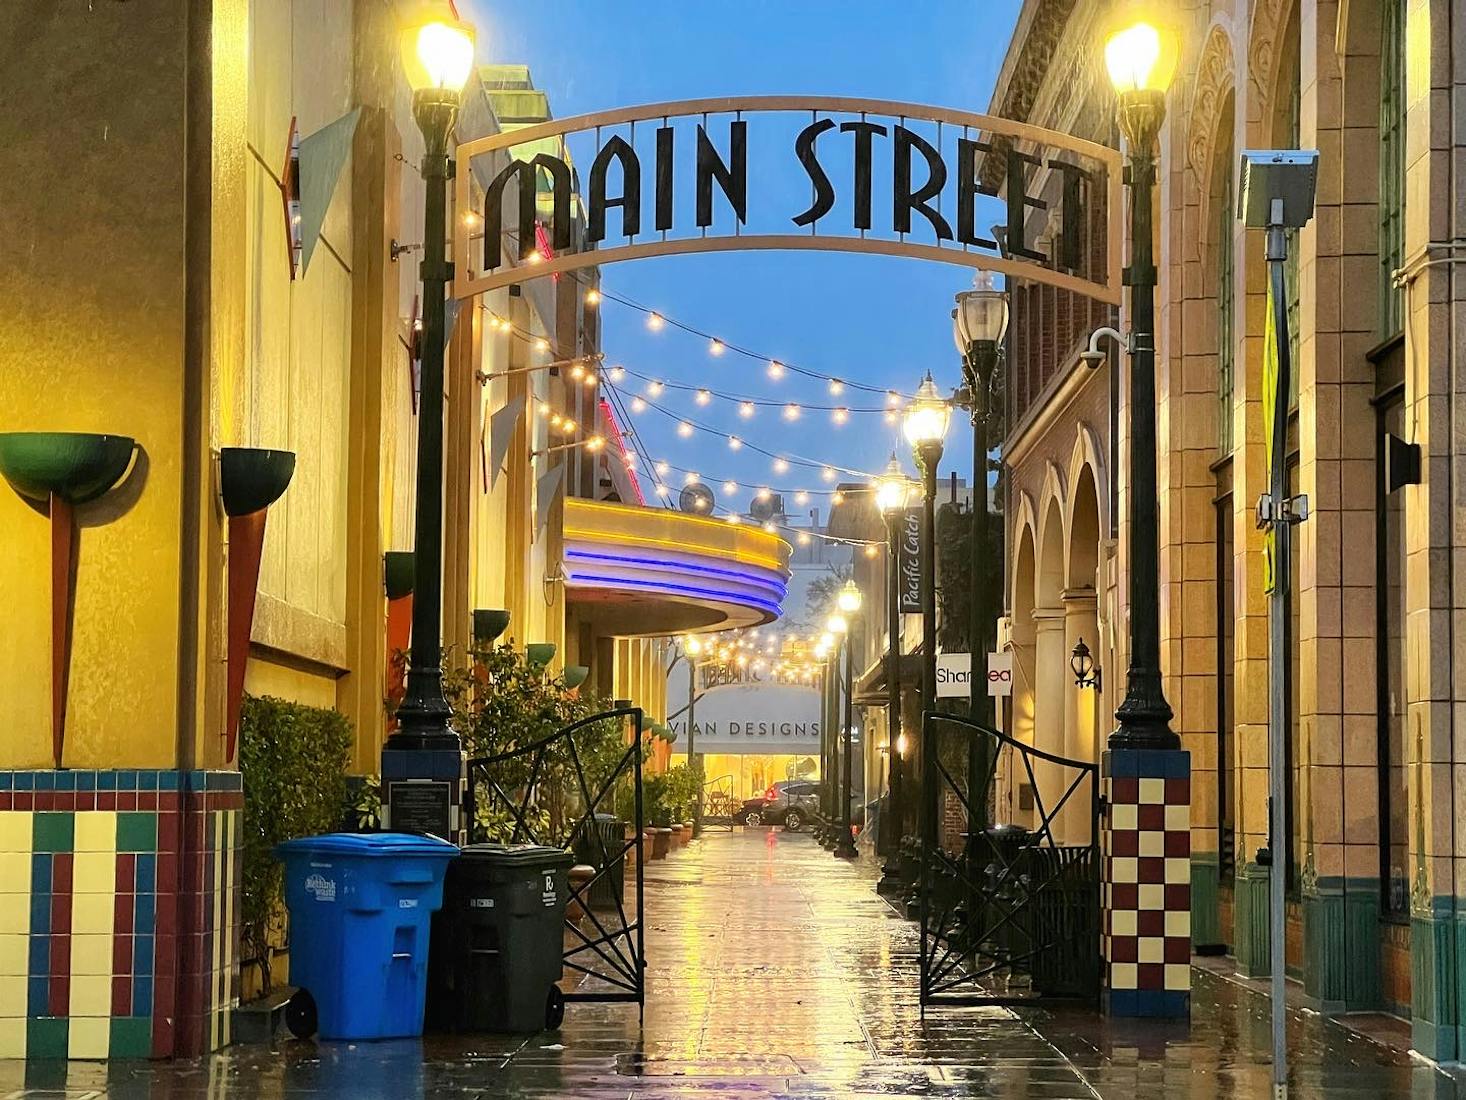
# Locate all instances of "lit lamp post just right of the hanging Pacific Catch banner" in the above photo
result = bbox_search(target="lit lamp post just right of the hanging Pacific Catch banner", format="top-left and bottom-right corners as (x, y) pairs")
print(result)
(902, 374), (951, 868)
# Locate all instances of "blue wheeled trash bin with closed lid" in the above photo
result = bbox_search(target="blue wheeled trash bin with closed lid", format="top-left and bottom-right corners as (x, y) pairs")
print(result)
(276, 833), (457, 1038)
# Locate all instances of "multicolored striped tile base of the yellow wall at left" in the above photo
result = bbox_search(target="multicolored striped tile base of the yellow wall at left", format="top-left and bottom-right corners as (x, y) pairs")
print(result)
(0, 770), (243, 1059)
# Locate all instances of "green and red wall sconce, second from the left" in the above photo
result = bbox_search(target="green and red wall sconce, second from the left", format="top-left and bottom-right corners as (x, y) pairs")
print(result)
(218, 447), (295, 763)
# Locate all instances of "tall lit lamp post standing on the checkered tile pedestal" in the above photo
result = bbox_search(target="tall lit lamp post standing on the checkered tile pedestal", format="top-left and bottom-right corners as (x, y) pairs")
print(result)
(1104, 23), (1182, 748)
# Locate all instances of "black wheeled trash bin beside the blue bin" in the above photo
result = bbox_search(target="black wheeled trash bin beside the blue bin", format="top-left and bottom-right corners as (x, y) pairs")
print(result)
(428, 843), (570, 1034)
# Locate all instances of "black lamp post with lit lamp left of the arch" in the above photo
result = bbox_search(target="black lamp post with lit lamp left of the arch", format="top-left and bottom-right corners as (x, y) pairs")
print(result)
(387, 21), (474, 751)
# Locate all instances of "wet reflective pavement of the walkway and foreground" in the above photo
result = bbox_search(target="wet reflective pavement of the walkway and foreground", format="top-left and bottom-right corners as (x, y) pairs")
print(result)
(0, 832), (1466, 1100)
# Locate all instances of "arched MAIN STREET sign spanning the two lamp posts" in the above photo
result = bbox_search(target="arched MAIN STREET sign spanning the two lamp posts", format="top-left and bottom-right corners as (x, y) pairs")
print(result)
(454, 95), (1121, 304)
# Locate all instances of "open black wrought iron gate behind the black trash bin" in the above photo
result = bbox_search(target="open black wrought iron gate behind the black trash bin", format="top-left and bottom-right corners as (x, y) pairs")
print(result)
(468, 707), (647, 1008)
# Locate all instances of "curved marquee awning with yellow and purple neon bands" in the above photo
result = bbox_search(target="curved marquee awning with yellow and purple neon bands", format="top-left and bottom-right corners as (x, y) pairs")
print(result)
(563, 499), (790, 638)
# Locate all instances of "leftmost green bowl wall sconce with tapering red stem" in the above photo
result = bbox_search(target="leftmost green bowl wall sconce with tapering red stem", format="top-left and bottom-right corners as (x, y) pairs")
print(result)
(0, 431), (138, 767)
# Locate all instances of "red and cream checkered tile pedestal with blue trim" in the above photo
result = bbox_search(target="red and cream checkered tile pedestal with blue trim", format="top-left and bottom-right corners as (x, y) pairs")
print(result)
(1100, 749), (1190, 1016)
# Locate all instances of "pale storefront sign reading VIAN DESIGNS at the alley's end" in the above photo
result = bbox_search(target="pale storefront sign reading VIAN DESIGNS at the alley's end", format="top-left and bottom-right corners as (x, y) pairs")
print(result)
(667, 683), (819, 755)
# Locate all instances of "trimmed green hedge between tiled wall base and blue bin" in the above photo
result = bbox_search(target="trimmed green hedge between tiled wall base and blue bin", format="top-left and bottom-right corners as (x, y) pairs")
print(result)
(239, 695), (353, 993)
